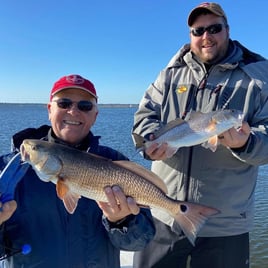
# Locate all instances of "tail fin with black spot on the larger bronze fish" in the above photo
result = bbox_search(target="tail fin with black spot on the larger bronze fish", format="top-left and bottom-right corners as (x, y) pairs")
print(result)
(173, 201), (220, 245)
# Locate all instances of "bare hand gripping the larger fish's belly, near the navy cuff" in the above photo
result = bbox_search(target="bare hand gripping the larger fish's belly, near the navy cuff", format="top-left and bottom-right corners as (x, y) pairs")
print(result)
(97, 186), (140, 222)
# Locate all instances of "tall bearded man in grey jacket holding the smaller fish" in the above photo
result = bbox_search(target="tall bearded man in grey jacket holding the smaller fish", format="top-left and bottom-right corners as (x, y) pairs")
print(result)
(133, 2), (268, 268)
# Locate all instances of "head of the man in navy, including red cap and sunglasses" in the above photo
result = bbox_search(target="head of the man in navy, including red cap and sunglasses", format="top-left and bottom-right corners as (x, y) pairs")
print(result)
(48, 75), (98, 145)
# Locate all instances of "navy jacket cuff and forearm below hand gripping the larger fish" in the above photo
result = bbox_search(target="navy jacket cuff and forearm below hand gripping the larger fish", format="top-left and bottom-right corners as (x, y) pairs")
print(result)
(103, 208), (155, 251)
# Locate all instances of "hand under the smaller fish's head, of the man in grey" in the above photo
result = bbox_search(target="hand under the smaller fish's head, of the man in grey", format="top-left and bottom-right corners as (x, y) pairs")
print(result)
(219, 122), (251, 148)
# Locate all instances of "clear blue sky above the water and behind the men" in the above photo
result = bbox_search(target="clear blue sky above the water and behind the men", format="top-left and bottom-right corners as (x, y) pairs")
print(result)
(0, 0), (268, 103)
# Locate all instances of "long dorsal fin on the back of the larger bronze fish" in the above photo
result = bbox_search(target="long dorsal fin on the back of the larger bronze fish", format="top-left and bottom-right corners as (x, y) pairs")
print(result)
(113, 160), (168, 194)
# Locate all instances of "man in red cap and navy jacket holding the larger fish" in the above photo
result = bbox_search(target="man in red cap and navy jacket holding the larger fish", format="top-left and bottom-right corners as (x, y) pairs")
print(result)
(0, 75), (155, 268)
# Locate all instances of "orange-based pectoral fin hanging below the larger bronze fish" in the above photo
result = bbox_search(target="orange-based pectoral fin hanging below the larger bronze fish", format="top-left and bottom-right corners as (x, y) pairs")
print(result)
(56, 179), (81, 214)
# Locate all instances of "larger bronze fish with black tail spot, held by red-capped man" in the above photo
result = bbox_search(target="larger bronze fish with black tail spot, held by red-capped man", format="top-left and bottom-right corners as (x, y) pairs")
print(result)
(21, 140), (219, 244)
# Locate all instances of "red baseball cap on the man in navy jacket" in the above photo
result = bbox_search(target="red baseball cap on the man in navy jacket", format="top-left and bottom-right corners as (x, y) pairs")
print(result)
(50, 74), (98, 101)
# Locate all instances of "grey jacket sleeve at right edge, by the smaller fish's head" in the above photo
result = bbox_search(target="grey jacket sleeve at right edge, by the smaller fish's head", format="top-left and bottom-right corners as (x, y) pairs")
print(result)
(229, 61), (268, 165)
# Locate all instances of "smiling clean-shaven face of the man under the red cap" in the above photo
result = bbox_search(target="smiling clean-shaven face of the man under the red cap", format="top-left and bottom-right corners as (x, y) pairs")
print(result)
(47, 89), (98, 144)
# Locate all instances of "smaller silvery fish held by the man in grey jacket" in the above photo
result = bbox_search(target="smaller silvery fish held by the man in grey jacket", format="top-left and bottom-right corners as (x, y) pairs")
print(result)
(133, 110), (244, 157)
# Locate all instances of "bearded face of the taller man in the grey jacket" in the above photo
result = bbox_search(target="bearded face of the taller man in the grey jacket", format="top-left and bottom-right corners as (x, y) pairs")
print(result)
(190, 14), (229, 64)
